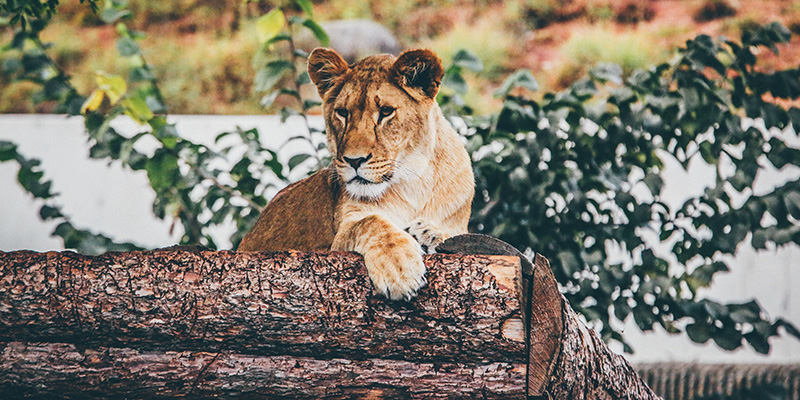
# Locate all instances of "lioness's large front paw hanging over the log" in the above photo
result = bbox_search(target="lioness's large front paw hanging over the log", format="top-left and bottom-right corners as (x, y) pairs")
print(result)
(364, 232), (426, 300)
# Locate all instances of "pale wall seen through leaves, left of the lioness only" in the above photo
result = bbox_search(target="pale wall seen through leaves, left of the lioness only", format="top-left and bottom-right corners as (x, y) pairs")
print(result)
(0, 115), (322, 251)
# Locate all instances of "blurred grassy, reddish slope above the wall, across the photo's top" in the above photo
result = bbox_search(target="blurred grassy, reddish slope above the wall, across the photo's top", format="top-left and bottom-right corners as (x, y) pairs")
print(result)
(0, 0), (800, 114)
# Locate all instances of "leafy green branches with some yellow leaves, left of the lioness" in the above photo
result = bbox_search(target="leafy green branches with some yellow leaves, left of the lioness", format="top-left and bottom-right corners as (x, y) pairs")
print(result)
(3, 1), (324, 253)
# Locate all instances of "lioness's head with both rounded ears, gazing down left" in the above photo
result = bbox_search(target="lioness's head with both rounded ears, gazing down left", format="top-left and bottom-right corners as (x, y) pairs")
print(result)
(308, 49), (444, 200)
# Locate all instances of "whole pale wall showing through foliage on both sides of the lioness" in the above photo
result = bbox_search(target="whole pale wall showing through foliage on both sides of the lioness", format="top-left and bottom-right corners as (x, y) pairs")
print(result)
(0, 115), (800, 363)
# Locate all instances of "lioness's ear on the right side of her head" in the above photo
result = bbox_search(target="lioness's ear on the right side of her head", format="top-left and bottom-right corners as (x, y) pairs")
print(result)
(392, 50), (444, 98)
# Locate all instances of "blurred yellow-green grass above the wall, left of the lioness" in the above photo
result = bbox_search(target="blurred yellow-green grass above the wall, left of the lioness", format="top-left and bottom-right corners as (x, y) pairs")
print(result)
(5, 15), (264, 114)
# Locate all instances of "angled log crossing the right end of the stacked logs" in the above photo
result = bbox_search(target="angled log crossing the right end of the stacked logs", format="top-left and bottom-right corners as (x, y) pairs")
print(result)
(438, 234), (658, 400)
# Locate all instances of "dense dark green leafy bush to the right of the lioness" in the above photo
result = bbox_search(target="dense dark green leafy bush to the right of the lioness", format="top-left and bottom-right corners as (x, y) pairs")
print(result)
(470, 24), (800, 353)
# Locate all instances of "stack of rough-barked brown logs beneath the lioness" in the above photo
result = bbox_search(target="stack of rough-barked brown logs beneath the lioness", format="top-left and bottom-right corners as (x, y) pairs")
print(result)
(0, 250), (655, 399)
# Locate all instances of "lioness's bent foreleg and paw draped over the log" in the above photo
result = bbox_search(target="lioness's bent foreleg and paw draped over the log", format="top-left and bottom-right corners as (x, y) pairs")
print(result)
(331, 215), (426, 300)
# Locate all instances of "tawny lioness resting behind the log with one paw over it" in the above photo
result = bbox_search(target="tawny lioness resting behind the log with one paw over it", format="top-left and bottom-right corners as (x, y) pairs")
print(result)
(239, 49), (475, 300)
